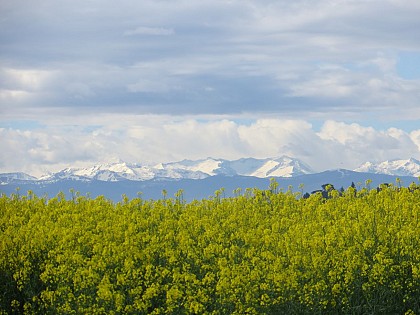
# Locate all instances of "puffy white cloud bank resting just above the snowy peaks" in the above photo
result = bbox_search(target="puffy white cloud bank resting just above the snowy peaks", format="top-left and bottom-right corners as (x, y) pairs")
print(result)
(0, 115), (420, 175)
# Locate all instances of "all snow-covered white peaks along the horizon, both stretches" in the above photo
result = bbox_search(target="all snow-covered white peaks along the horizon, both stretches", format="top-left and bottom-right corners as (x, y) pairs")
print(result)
(0, 155), (420, 185)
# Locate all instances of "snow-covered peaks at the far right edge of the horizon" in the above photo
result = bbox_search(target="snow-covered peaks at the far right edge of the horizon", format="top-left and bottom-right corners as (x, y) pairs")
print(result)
(354, 158), (420, 177)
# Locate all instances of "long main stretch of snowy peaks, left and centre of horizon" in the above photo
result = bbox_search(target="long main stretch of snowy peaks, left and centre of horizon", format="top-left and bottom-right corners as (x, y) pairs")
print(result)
(32, 156), (313, 181)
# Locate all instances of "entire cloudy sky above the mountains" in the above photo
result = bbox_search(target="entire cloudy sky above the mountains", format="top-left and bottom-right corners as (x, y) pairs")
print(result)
(0, 0), (420, 176)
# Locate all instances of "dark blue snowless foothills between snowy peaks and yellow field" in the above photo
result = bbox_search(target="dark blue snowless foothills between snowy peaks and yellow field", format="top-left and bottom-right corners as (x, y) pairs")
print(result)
(0, 170), (417, 202)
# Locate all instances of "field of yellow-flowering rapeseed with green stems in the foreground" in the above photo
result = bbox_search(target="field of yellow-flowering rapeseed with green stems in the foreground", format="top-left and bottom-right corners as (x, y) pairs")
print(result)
(0, 181), (420, 314)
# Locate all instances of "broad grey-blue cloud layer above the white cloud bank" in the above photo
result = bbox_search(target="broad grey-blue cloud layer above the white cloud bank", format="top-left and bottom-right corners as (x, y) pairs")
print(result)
(0, 0), (420, 119)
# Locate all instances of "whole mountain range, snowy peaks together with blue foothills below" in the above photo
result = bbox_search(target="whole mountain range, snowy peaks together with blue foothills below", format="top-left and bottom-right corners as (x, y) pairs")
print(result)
(0, 156), (420, 201)
